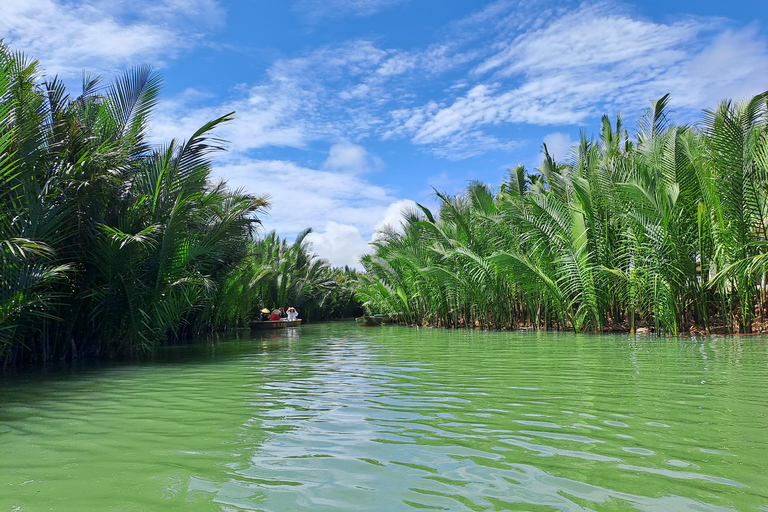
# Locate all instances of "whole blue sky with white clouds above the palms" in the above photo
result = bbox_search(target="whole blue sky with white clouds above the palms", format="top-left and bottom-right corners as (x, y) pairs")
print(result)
(0, 0), (768, 265)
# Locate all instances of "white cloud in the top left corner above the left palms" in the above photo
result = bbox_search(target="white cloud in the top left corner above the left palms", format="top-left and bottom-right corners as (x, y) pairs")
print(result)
(0, 0), (223, 78)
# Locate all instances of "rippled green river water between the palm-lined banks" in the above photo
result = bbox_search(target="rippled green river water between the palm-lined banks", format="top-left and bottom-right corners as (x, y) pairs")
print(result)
(0, 323), (768, 512)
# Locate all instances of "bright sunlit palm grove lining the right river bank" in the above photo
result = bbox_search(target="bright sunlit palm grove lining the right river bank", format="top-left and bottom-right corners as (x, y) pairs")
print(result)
(358, 95), (768, 334)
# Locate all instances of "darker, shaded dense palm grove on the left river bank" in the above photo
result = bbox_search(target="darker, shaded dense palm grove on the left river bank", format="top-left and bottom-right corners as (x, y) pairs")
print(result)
(0, 44), (357, 365)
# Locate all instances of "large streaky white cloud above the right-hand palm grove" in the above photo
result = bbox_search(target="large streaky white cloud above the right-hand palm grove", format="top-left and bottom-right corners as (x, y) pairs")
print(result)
(384, 2), (768, 152)
